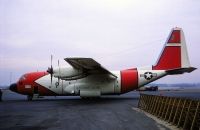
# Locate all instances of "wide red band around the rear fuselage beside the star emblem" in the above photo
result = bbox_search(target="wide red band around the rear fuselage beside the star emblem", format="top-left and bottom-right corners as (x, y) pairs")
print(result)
(121, 69), (138, 93)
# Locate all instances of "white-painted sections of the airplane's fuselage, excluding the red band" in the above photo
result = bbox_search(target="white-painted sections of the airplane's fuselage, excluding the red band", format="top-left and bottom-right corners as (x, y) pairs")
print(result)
(35, 70), (166, 97)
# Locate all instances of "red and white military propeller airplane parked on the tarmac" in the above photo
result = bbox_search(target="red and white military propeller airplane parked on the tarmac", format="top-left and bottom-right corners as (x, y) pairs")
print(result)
(9, 27), (196, 100)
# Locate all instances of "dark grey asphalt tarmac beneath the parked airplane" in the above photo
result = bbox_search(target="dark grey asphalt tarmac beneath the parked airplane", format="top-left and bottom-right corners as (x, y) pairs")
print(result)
(0, 91), (200, 130)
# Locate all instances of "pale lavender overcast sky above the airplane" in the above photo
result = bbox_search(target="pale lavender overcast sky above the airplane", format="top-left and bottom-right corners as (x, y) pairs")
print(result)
(0, 0), (200, 85)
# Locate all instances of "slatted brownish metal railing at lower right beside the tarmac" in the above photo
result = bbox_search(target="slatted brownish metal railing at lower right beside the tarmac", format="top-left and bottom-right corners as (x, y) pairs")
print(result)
(138, 94), (200, 130)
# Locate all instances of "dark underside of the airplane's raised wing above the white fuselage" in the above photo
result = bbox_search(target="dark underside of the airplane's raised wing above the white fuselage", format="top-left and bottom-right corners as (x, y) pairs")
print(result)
(64, 58), (117, 78)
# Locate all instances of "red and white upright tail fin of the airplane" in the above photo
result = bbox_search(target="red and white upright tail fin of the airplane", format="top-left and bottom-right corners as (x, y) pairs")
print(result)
(153, 27), (193, 70)
